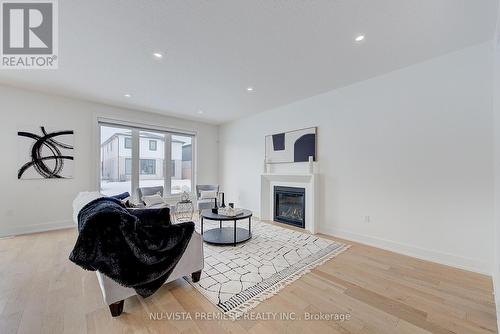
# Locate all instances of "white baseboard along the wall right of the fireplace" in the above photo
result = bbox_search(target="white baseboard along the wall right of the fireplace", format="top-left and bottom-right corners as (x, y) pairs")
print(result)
(319, 226), (492, 276)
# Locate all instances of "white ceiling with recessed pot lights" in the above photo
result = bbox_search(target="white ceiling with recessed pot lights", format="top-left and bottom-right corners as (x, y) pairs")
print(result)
(0, 0), (497, 123)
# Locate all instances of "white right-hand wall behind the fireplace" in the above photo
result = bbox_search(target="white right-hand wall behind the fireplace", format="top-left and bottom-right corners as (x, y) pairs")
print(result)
(219, 43), (494, 273)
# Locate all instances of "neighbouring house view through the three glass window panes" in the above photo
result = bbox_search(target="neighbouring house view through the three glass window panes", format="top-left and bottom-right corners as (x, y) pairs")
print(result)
(101, 132), (192, 182)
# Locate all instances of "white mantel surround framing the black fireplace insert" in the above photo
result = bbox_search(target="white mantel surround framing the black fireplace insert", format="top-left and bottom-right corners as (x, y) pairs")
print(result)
(260, 173), (318, 234)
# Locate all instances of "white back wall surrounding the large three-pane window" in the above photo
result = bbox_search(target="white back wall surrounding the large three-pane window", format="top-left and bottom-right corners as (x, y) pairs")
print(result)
(0, 86), (218, 237)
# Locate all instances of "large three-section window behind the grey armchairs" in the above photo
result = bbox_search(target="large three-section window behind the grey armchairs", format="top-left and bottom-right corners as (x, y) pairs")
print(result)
(99, 121), (194, 196)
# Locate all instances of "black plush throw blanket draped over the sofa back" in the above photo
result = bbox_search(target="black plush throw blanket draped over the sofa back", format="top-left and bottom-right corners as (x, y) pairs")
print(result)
(69, 197), (194, 297)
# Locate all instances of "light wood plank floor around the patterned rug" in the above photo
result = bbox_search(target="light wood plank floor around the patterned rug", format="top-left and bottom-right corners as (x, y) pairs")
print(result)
(0, 222), (497, 334)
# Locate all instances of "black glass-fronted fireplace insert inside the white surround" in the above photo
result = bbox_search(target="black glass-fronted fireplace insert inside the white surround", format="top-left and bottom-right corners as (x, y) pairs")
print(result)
(274, 186), (306, 228)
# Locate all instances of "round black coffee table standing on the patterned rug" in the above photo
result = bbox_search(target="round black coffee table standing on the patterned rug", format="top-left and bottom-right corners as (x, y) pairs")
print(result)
(201, 210), (252, 246)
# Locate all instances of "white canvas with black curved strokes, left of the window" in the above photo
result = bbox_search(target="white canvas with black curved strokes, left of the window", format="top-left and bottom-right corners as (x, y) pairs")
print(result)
(17, 126), (74, 179)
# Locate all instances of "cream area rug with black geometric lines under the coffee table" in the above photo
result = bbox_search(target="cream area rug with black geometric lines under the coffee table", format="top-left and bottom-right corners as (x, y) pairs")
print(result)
(187, 220), (350, 319)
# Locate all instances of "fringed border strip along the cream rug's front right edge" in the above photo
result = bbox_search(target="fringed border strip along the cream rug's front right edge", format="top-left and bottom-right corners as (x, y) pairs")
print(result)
(225, 245), (351, 320)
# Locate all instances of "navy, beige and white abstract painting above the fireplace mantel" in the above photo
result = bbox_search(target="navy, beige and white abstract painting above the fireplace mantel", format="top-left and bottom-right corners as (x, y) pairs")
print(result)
(266, 127), (317, 164)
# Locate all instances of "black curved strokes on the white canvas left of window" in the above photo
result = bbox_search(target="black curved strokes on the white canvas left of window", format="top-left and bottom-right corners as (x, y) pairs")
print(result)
(17, 126), (74, 179)
